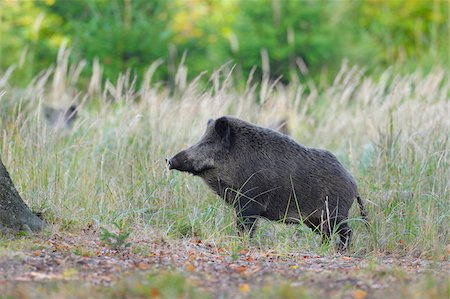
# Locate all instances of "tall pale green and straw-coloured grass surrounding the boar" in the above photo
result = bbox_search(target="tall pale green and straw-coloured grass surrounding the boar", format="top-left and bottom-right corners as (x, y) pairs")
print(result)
(0, 51), (450, 257)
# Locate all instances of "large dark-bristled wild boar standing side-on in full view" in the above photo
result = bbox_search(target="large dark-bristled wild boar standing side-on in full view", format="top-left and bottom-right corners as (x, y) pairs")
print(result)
(167, 116), (366, 250)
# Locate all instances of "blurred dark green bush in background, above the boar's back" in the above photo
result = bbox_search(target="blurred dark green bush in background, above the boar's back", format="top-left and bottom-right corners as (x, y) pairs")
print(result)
(230, 0), (343, 77)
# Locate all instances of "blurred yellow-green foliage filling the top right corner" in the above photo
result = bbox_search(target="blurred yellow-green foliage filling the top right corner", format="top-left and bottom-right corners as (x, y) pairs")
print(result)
(343, 0), (450, 70)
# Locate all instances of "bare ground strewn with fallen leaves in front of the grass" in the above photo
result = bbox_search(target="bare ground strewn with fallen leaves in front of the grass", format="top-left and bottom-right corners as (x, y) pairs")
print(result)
(0, 233), (449, 299)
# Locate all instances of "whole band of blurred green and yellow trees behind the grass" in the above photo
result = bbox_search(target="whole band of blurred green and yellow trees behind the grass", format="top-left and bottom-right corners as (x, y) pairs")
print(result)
(0, 0), (450, 84)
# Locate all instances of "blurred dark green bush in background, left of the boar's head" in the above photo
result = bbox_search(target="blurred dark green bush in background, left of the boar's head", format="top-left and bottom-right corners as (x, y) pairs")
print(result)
(39, 0), (171, 80)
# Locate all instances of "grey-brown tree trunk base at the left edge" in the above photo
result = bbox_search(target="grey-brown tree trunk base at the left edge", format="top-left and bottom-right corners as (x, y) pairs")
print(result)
(0, 158), (44, 232)
